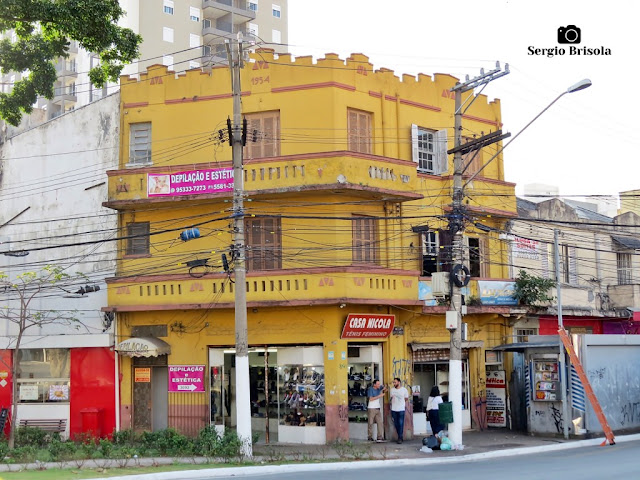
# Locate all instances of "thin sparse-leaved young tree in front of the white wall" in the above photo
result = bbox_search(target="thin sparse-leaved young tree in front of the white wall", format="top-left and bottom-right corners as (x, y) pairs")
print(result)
(0, 266), (79, 448)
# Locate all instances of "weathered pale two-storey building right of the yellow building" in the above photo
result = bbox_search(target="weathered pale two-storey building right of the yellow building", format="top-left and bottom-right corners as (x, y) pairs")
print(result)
(511, 199), (640, 340)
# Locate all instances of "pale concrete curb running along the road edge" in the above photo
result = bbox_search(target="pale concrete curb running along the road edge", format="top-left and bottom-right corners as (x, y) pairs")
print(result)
(96, 434), (640, 480)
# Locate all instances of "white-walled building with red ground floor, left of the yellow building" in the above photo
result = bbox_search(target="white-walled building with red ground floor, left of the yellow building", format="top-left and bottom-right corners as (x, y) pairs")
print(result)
(0, 93), (120, 436)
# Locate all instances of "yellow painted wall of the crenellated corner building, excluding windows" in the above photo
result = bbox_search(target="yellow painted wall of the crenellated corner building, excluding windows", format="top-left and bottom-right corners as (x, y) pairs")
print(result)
(108, 50), (516, 436)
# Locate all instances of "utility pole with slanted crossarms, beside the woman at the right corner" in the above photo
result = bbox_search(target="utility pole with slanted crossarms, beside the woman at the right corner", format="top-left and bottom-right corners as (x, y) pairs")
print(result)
(446, 63), (509, 445)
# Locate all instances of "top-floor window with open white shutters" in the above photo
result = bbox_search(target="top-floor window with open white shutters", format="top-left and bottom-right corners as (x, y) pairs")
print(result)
(411, 125), (447, 175)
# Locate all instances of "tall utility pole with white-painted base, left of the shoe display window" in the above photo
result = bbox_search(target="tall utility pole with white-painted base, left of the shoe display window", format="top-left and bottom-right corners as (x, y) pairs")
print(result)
(226, 34), (253, 458)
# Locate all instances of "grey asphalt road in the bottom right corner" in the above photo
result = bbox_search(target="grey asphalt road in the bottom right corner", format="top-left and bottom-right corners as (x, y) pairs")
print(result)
(192, 441), (640, 480)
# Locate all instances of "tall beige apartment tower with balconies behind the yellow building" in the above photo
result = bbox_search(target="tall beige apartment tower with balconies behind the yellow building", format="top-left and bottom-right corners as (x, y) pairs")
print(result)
(0, 0), (289, 138)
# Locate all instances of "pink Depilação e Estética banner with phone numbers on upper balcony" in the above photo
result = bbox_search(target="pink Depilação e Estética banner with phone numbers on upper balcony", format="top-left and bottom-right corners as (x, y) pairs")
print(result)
(147, 168), (233, 197)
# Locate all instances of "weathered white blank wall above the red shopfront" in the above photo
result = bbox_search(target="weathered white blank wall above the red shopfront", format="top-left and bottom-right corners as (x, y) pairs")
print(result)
(0, 94), (120, 348)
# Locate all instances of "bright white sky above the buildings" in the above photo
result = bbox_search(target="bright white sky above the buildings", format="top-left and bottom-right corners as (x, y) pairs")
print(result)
(288, 0), (640, 199)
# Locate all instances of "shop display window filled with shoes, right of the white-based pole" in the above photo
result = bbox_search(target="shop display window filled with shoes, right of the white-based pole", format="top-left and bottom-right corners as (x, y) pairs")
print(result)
(278, 364), (325, 427)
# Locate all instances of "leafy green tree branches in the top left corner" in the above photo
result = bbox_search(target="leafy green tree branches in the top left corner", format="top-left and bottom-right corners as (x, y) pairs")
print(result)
(0, 0), (142, 125)
